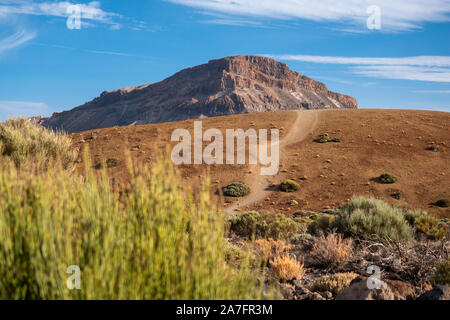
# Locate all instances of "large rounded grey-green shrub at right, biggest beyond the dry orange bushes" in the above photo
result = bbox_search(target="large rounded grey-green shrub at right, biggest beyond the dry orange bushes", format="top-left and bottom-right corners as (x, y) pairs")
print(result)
(333, 197), (413, 241)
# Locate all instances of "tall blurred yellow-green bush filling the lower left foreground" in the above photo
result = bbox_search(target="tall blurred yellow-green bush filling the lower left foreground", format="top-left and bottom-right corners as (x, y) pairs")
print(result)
(0, 161), (260, 299)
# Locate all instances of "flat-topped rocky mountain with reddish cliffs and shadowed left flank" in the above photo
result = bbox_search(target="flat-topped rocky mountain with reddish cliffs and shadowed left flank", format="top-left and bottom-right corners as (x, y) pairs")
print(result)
(40, 56), (358, 133)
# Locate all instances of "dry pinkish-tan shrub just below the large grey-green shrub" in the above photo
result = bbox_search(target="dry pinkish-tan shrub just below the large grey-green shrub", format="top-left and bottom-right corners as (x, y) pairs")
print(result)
(310, 233), (353, 268)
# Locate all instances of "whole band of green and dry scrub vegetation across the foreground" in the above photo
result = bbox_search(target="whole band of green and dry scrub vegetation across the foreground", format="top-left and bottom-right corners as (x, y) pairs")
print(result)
(0, 120), (449, 299)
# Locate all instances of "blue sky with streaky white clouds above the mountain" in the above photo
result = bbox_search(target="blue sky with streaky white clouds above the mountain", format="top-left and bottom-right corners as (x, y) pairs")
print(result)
(0, 0), (450, 120)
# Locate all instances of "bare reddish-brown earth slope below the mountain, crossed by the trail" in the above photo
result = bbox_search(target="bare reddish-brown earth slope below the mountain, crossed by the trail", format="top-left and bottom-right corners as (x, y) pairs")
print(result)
(72, 110), (450, 218)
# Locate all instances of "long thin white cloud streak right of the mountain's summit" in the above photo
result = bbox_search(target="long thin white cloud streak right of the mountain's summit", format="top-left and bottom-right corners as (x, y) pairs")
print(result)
(265, 55), (450, 82)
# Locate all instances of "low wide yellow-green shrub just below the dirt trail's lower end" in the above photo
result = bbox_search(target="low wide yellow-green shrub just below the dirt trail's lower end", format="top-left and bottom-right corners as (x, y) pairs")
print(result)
(228, 211), (301, 240)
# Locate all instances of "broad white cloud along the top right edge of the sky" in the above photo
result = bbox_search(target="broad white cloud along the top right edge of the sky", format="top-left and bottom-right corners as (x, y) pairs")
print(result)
(167, 0), (450, 31)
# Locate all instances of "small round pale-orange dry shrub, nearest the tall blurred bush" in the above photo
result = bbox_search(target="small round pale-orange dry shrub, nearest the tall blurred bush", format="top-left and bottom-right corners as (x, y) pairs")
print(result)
(270, 254), (306, 282)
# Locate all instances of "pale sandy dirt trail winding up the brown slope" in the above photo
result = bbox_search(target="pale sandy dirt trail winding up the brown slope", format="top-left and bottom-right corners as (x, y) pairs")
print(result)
(224, 110), (319, 215)
